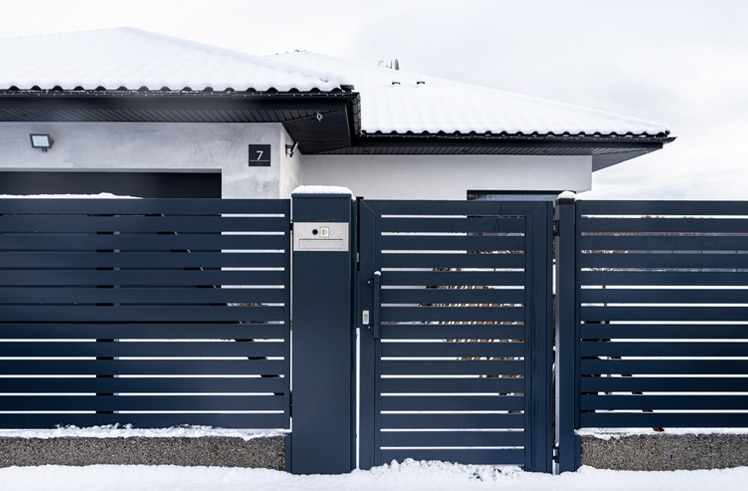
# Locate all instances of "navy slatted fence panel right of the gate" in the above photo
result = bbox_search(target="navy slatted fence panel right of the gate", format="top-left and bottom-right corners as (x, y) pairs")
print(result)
(576, 201), (748, 428)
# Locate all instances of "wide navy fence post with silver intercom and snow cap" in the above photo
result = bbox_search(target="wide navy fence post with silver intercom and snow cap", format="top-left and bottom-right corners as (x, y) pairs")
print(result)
(287, 187), (355, 474)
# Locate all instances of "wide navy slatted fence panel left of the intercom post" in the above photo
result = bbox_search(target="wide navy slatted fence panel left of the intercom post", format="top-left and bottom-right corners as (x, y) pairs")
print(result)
(0, 199), (290, 428)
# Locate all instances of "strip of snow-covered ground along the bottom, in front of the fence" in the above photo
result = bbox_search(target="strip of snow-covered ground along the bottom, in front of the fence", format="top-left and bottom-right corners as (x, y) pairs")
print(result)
(0, 461), (748, 491)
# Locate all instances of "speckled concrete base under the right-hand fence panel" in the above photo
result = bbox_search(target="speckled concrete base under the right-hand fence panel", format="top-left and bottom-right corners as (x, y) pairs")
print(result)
(582, 433), (748, 471)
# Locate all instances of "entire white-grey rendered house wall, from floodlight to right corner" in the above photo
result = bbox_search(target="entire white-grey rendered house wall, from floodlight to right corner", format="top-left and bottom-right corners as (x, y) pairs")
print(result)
(0, 122), (592, 200)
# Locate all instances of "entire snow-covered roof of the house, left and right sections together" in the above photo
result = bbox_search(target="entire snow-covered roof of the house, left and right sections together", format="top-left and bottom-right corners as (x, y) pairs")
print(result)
(0, 28), (670, 137)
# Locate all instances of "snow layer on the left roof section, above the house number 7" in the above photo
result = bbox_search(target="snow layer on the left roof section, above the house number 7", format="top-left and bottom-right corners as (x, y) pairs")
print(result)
(0, 27), (343, 92)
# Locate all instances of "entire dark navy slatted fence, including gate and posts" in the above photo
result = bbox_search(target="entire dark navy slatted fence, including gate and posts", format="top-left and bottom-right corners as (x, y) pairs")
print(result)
(0, 193), (748, 473)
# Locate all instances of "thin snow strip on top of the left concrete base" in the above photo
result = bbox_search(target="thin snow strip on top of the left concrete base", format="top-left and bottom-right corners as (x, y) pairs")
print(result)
(0, 425), (284, 440)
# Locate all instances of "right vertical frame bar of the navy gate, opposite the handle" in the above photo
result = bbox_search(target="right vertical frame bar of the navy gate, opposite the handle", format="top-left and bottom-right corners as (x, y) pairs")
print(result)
(525, 201), (553, 472)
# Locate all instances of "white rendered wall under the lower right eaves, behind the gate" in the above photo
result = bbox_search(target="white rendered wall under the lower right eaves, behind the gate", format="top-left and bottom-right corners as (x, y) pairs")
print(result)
(298, 155), (592, 200)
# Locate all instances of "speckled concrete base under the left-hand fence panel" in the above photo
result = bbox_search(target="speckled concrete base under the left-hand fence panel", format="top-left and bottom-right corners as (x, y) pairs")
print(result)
(0, 436), (286, 470)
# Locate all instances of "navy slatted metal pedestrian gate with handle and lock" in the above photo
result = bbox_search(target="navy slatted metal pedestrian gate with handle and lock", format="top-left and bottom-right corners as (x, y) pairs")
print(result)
(356, 200), (553, 472)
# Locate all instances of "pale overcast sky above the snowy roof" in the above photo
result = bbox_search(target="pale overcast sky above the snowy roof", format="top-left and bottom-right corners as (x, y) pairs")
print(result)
(0, 0), (748, 199)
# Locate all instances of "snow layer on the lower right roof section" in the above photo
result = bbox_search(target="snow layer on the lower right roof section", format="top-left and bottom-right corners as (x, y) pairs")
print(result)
(273, 51), (670, 137)
